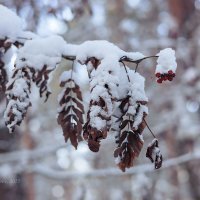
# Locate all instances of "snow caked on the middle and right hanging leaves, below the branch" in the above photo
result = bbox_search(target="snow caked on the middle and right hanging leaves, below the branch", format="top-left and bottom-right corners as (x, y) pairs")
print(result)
(90, 60), (148, 129)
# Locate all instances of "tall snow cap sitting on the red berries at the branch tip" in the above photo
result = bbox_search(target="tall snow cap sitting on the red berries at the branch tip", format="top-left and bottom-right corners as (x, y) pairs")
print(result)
(156, 48), (177, 74)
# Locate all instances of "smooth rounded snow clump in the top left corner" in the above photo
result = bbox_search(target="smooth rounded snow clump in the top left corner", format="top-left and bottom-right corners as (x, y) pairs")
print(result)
(0, 5), (23, 40)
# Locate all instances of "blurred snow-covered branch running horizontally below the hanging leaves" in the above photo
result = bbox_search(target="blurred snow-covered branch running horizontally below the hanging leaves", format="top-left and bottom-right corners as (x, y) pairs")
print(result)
(26, 151), (200, 180)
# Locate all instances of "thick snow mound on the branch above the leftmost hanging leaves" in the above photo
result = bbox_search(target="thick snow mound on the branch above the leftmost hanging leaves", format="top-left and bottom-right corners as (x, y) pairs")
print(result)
(16, 36), (66, 70)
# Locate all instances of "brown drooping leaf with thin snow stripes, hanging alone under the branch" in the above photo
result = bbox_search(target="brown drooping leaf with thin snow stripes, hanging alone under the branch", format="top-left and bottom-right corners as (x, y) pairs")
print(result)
(58, 79), (84, 149)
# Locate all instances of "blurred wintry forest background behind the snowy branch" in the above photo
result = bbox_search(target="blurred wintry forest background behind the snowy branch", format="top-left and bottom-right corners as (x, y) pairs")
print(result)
(0, 0), (200, 200)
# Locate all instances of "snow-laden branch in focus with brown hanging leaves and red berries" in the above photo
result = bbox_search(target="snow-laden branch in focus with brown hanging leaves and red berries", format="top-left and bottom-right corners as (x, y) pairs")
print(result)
(0, 6), (177, 171)
